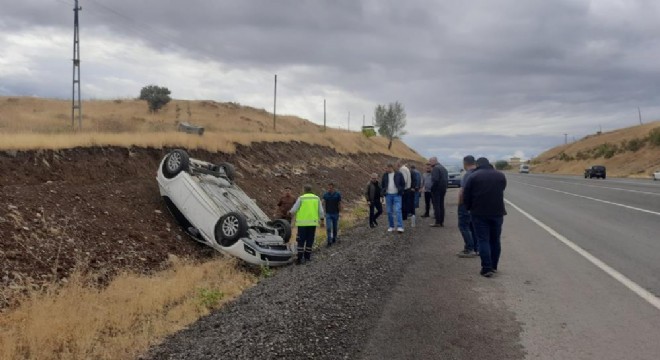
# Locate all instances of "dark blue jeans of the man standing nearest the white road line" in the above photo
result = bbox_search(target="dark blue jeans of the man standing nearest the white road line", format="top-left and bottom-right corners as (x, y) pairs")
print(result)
(472, 214), (504, 272)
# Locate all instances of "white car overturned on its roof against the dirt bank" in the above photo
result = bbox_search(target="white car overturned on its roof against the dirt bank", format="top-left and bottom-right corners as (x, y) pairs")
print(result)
(156, 150), (293, 266)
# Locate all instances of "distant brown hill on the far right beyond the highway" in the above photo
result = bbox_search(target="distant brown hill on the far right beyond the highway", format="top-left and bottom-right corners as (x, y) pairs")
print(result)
(532, 121), (660, 178)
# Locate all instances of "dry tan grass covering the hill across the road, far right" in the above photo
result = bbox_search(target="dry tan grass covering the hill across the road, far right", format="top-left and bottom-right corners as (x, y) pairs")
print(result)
(532, 121), (660, 178)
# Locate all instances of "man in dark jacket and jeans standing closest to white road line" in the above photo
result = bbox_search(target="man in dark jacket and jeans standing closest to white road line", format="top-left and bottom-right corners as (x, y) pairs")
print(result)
(463, 158), (506, 277)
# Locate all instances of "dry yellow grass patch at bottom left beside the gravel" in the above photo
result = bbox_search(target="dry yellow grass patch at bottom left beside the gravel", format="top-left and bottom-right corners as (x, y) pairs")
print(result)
(0, 258), (256, 360)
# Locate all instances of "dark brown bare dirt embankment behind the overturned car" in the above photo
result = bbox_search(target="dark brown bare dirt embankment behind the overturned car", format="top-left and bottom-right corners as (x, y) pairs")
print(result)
(0, 142), (404, 308)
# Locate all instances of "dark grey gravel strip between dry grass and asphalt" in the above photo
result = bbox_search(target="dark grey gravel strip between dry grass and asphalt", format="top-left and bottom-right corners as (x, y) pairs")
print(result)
(144, 218), (414, 359)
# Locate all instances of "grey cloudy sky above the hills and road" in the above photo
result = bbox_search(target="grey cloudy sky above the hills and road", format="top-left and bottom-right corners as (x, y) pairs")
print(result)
(0, 0), (660, 163)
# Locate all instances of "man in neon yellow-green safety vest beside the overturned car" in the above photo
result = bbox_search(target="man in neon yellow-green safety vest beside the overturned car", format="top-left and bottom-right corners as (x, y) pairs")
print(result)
(289, 185), (323, 265)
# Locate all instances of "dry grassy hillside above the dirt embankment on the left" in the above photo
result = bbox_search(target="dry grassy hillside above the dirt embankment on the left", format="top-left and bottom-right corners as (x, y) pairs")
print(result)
(0, 97), (420, 159)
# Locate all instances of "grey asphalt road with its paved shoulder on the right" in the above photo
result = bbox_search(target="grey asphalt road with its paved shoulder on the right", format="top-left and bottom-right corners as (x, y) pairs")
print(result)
(363, 174), (660, 360)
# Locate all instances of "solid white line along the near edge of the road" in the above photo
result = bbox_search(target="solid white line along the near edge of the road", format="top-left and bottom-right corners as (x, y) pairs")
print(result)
(504, 199), (660, 310)
